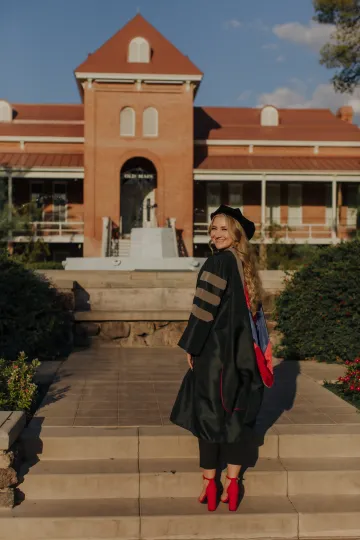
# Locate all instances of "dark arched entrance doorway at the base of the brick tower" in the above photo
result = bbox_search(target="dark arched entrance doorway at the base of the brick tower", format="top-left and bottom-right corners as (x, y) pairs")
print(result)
(120, 157), (157, 236)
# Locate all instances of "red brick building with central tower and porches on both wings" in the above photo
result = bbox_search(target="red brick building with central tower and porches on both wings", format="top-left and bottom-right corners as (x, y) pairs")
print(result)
(0, 15), (360, 260)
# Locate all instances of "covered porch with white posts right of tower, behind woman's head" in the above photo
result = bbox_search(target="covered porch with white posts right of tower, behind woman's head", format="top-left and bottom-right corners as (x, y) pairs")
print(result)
(194, 163), (360, 245)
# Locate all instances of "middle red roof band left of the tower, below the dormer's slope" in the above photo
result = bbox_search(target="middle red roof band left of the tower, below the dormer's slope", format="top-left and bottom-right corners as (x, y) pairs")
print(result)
(0, 122), (84, 137)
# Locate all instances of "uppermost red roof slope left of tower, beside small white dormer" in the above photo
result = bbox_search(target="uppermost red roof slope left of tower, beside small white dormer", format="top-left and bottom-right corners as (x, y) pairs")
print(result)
(11, 103), (84, 122)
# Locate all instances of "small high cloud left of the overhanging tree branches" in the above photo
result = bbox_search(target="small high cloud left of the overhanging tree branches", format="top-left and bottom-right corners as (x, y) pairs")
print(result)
(272, 21), (335, 51)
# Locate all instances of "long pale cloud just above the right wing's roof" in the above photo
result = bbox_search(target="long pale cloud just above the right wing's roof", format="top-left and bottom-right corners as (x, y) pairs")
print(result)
(258, 81), (360, 114)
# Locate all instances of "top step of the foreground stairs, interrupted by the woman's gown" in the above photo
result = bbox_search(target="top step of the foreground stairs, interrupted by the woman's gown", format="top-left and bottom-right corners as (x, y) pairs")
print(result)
(22, 424), (360, 464)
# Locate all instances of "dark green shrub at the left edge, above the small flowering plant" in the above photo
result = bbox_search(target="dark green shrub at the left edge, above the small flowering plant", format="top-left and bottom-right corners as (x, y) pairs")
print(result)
(0, 252), (72, 360)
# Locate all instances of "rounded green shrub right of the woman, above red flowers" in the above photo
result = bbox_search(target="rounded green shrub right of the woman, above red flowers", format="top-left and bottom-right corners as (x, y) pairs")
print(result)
(275, 240), (360, 362)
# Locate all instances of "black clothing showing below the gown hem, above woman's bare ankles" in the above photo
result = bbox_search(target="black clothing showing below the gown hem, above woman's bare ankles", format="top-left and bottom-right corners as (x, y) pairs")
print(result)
(199, 439), (242, 469)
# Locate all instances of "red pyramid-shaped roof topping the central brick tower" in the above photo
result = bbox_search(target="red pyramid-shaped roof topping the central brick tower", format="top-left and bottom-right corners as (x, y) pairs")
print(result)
(75, 15), (202, 75)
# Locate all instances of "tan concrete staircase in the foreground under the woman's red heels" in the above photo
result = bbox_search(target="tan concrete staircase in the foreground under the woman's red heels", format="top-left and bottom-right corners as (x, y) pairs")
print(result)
(0, 424), (360, 540)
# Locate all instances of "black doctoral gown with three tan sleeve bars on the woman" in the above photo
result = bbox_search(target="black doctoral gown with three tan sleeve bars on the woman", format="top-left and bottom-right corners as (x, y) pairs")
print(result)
(170, 250), (264, 443)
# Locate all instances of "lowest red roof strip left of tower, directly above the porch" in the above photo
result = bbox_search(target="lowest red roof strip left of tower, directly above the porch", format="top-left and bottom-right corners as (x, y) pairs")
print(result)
(0, 152), (84, 169)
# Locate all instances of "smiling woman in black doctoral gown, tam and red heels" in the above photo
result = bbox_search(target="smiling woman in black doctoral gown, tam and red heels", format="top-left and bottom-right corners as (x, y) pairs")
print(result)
(170, 205), (273, 511)
